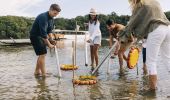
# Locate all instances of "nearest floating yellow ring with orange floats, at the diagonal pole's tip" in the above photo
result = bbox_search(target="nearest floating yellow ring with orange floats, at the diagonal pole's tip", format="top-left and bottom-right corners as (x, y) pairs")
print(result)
(73, 75), (97, 85)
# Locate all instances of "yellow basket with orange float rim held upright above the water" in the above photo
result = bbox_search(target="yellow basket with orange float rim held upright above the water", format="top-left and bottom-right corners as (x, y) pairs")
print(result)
(127, 47), (139, 69)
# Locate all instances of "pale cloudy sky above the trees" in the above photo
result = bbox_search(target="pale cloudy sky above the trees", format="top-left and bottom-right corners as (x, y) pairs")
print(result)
(0, 0), (170, 18)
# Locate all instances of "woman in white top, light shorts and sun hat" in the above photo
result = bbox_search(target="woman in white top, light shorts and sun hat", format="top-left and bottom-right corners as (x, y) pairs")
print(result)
(87, 8), (101, 67)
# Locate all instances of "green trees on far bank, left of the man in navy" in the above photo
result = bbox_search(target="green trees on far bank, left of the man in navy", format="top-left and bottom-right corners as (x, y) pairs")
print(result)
(0, 16), (32, 39)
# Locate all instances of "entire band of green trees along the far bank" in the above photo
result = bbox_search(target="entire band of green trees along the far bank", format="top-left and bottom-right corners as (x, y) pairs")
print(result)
(0, 11), (170, 39)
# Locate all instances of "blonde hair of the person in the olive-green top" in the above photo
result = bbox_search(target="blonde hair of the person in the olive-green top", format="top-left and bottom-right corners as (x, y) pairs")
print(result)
(129, 0), (144, 13)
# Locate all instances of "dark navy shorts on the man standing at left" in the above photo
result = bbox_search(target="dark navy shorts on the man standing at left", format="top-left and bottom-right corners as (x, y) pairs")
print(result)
(30, 37), (47, 55)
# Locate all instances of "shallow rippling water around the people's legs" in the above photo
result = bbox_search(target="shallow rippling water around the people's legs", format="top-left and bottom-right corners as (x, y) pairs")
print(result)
(0, 37), (170, 100)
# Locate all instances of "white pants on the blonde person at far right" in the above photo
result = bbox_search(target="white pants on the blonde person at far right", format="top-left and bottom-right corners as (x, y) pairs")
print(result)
(146, 25), (170, 75)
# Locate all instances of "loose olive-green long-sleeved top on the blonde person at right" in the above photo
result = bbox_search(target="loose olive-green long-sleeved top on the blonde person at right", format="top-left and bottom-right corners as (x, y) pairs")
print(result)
(119, 0), (170, 42)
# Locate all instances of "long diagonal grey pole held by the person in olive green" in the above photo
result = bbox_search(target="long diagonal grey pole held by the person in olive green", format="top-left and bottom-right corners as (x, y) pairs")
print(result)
(91, 41), (118, 75)
